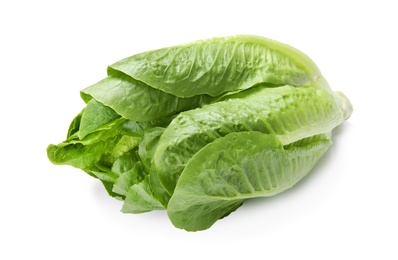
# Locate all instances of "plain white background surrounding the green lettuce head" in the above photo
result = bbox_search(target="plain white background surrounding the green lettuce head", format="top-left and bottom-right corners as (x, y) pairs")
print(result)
(0, 0), (398, 259)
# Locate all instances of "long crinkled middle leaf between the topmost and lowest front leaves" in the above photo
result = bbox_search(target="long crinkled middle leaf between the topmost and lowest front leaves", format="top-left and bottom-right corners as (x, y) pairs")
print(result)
(154, 86), (344, 194)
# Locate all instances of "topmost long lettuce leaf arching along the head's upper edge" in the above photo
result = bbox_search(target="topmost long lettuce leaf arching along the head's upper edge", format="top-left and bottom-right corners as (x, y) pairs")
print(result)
(108, 35), (329, 98)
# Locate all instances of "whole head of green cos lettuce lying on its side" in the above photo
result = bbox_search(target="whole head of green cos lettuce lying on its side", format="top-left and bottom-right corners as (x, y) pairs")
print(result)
(47, 35), (352, 231)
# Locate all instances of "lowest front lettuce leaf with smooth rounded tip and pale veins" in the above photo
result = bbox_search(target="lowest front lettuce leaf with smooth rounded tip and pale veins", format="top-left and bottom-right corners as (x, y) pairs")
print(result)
(167, 131), (331, 231)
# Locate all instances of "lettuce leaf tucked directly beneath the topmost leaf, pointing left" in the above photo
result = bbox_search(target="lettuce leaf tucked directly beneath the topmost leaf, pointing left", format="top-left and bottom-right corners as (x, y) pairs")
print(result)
(81, 72), (214, 122)
